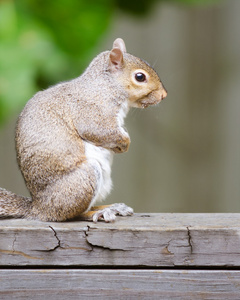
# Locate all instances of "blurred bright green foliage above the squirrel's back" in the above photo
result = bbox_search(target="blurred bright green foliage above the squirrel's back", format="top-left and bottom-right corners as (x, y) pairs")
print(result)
(0, 0), (218, 123)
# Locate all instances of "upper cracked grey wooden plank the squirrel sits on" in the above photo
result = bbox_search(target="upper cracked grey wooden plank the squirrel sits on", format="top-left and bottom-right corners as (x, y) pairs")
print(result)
(0, 214), (240, 267)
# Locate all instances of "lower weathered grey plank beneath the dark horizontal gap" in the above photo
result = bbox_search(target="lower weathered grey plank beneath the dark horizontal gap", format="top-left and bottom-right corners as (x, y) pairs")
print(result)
(0, 269), (240, 300)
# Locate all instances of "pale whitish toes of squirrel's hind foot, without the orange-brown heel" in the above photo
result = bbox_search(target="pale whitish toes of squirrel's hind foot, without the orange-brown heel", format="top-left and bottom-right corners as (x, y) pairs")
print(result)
(93, 203), (133, 223)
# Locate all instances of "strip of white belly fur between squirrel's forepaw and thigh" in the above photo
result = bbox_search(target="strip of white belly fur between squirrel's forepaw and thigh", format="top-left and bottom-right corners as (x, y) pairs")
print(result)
(84, 141), (113, 209)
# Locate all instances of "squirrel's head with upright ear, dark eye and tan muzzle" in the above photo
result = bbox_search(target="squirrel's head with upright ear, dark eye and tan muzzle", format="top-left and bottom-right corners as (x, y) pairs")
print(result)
(109, 38), (167, 108)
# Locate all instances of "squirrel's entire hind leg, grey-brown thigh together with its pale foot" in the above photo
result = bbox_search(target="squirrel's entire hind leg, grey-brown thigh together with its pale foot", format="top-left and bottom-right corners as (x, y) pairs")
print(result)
(30, 160), (133, 222)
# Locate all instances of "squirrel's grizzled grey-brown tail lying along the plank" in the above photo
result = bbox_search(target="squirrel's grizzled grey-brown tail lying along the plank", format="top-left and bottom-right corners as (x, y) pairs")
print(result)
(0, 188), (32, 218)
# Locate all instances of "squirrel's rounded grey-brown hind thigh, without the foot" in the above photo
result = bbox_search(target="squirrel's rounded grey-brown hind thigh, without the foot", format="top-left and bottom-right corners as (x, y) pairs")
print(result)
(30, 163), (97, 222)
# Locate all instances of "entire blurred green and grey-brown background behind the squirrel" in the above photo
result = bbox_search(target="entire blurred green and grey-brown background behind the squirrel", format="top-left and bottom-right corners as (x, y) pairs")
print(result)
(0, 0), (240, 212)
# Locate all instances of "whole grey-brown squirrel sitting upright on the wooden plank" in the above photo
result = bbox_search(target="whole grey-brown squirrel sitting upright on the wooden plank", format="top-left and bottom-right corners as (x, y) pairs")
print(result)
(0, 38), (167, 222)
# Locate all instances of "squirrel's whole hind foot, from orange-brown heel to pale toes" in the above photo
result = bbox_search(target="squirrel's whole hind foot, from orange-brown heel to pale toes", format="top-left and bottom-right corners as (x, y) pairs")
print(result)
(81, 203), (133, 223)
